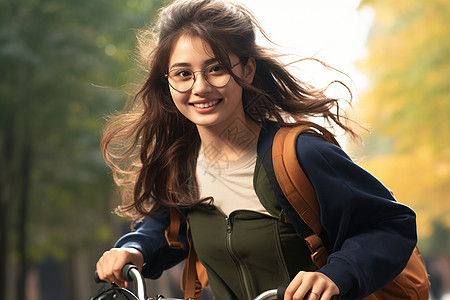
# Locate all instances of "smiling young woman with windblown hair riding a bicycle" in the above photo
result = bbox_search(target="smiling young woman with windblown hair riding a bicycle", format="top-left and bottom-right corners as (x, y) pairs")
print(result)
(97, 0), (416, 300)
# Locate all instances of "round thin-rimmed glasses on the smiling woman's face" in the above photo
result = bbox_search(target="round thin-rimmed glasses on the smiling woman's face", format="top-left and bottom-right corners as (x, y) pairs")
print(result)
(165, 62), (240, 93)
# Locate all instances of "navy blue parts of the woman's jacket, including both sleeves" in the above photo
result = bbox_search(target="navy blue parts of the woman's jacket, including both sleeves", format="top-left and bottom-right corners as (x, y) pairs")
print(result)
(116, 123), (417, 299)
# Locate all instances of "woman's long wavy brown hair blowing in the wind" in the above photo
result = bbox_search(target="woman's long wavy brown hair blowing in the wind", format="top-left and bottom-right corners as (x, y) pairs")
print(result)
(101, 0), (355, 218)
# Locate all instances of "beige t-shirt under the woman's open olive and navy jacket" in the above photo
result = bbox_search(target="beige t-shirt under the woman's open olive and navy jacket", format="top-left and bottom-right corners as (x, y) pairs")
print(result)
(197, 147), (269, 216)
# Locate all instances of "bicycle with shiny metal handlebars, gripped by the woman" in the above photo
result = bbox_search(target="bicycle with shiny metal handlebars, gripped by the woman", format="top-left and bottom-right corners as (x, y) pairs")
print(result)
(89, 264), (338, 300)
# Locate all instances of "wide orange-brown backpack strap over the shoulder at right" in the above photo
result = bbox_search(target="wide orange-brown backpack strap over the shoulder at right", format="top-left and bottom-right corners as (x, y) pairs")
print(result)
(272, 125), (339, 268)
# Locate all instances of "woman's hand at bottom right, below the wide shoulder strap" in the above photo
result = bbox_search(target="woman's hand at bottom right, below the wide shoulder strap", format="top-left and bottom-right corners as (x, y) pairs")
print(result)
(284, 271), (339, 300)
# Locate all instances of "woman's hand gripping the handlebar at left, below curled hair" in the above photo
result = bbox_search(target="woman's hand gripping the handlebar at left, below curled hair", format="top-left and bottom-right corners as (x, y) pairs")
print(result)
(97, 248), (144, 288)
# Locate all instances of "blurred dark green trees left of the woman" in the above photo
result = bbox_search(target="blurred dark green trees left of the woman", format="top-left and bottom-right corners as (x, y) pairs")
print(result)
(0, 0), (164, 299)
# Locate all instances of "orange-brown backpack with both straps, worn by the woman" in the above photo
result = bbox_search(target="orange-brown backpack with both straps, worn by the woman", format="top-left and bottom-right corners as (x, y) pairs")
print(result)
(166, 124), (430, 300)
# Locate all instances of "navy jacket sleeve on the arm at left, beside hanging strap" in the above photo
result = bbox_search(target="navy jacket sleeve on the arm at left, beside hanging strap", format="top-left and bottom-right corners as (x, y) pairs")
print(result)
(114, 208), (189, 279)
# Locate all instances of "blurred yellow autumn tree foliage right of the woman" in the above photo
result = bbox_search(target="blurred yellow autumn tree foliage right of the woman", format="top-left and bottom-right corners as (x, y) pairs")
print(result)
(358, 0), (450, 254)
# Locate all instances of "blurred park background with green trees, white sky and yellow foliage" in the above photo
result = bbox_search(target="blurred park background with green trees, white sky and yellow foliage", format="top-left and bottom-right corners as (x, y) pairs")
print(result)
(0, 0), (450, 300)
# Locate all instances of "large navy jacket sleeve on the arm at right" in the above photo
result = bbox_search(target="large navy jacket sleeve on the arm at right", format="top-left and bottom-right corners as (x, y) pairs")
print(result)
(297, 135), (417, 298)
